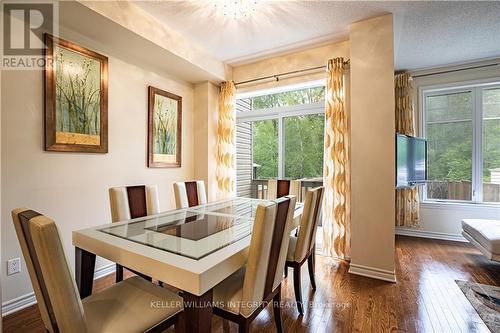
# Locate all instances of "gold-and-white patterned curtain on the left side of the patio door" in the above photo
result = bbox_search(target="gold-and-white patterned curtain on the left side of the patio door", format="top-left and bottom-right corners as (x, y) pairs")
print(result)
(216, 81), (236, 199)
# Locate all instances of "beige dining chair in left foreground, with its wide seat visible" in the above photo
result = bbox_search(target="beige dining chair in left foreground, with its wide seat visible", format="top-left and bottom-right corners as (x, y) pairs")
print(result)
(12, 208), (182, 333)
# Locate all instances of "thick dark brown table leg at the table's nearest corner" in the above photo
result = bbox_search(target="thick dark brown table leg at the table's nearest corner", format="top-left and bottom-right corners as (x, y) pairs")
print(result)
(183, 289), (213, 333)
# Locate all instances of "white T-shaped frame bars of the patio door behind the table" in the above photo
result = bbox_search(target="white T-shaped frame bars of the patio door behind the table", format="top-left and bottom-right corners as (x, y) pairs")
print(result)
(236, 96), (325, 179)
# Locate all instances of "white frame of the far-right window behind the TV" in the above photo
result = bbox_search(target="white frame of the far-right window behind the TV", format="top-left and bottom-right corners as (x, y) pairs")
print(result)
(418, 77), (500, 207)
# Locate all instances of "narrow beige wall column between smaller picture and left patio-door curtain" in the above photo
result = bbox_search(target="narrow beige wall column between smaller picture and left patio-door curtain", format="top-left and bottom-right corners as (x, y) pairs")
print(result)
(193, 82), (219, 201)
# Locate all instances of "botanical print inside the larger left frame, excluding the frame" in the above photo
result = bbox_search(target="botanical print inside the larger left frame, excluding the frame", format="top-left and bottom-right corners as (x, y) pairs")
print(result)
(54, 45), (101, 146)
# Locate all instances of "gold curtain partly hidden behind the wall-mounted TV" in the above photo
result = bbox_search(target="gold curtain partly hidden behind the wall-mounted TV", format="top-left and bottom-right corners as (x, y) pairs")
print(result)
(394, 73), (419, 227)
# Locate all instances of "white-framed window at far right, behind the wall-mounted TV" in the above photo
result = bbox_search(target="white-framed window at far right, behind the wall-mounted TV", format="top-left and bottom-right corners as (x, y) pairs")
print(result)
(422, 83), (500, 203)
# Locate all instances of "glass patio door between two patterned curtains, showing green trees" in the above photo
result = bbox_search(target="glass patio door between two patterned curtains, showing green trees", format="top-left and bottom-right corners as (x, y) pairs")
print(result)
(236, 86), (325, 196)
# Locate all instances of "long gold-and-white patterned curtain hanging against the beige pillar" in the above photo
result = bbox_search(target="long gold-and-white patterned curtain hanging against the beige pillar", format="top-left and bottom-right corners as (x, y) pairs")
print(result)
(323, 58), (351, 259)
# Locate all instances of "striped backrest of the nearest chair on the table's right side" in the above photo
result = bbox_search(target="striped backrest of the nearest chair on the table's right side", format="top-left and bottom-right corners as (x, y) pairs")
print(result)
(240, 196), (296, 318)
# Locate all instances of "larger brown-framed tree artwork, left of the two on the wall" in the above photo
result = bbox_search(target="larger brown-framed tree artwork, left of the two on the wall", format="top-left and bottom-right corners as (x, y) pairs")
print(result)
(44, 34), (108, 153)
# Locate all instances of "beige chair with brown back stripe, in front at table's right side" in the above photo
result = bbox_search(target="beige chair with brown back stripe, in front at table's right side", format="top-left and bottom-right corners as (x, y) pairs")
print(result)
(213, 196), (295, 332)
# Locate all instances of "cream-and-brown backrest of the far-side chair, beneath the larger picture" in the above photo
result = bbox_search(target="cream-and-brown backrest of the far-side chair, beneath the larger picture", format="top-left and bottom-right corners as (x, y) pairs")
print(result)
(109, 185), (160, 222)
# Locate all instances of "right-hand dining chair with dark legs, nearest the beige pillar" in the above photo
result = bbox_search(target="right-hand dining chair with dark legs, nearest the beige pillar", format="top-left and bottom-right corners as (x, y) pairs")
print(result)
(285, 186), (324, 314)
